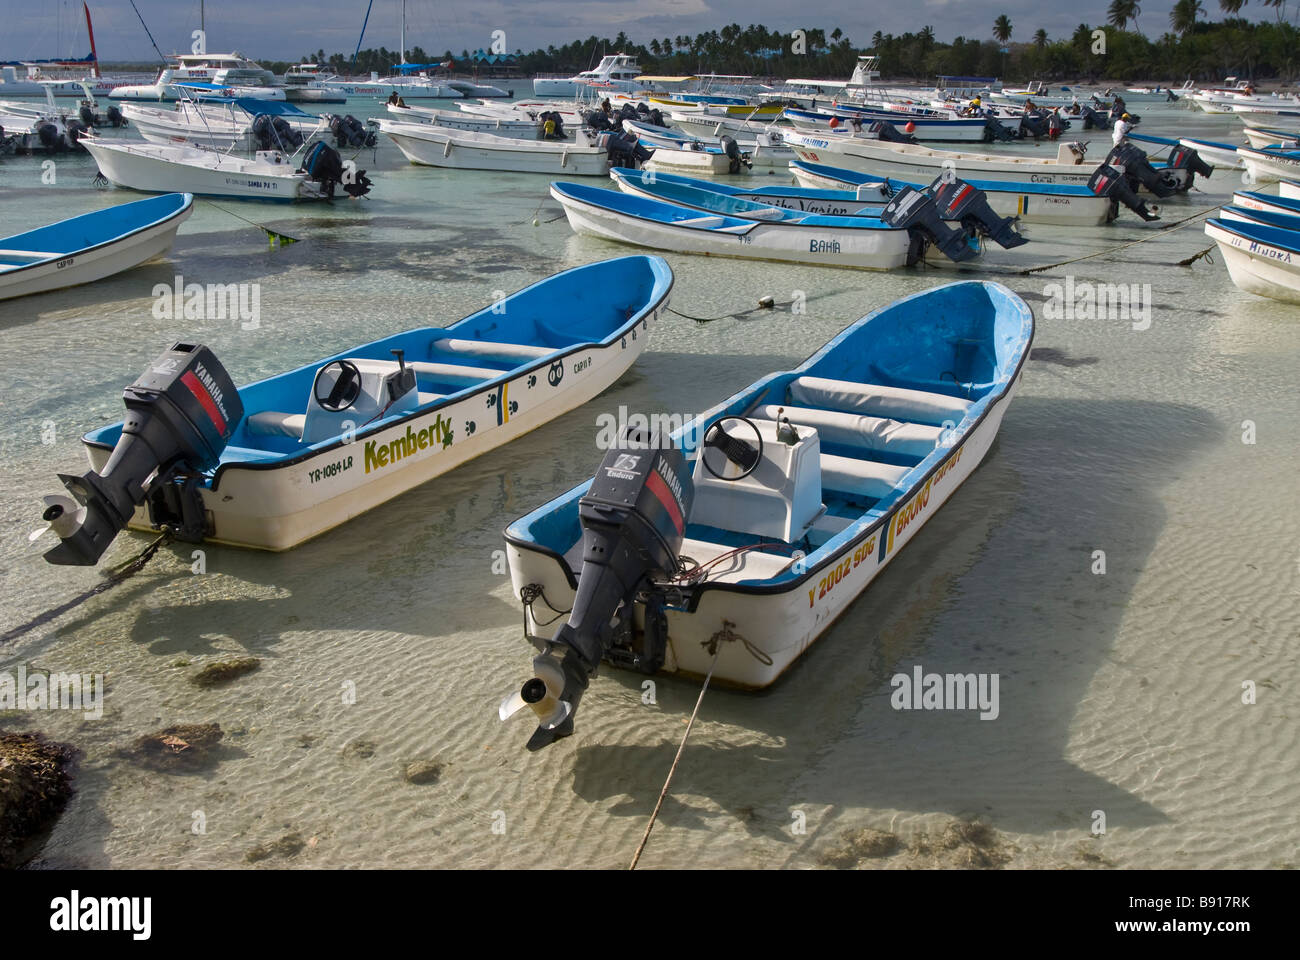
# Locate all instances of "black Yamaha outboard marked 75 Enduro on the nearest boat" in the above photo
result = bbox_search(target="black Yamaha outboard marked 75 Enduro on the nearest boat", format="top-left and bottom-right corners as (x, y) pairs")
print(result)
(498, 428), (696, 751)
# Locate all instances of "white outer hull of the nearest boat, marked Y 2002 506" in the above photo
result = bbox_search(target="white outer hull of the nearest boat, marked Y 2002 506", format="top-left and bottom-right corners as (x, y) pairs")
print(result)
(506, 369), (1019, 689)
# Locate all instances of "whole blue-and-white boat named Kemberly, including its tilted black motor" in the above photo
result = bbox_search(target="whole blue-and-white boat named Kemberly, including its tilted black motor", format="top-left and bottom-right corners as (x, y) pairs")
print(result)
(35, 256), (672, 565)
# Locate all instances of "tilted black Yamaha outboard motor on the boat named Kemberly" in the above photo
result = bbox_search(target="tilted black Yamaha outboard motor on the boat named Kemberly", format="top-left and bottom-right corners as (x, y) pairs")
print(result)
(43, 343), (243, 566)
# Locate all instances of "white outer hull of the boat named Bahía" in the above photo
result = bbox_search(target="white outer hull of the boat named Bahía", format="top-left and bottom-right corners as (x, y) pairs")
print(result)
(551, 180), (910, 271)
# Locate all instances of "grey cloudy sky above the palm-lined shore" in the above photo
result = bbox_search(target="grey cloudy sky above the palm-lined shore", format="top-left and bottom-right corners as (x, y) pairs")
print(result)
(0, 0), (1232, 61)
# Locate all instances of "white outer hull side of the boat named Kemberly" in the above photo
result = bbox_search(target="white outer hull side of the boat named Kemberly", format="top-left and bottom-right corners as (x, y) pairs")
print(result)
(94, 306), (668, 550)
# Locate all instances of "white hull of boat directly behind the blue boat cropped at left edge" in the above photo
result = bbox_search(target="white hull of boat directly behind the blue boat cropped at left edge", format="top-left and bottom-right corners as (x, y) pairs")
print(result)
(82, 139), (319, 200)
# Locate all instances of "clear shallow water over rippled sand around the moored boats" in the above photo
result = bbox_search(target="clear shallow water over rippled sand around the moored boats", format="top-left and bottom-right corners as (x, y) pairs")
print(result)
(0, 98), (1300, 868)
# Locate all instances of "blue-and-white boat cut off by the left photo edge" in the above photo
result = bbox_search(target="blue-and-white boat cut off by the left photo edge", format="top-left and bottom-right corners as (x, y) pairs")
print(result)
(0, 194), (194, 300)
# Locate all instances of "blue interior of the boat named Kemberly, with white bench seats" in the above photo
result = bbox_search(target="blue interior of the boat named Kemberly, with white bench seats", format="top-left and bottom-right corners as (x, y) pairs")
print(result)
(86, 256), (672, 470)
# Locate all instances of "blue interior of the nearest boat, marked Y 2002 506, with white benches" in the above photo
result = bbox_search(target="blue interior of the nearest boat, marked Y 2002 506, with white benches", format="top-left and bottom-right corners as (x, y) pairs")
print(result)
(507, 281), (1034, 584)
